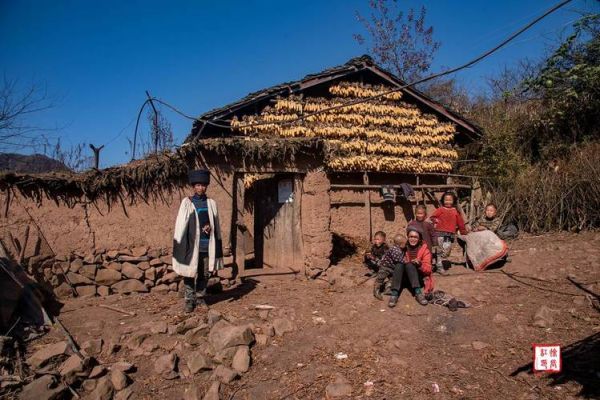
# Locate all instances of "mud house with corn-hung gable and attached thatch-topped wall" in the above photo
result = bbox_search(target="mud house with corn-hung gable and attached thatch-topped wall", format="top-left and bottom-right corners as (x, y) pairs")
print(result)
(0, 56), (480, 292)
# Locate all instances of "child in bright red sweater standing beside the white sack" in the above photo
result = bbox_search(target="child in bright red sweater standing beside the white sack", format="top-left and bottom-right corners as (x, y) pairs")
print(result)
(431, 192), (467, 275)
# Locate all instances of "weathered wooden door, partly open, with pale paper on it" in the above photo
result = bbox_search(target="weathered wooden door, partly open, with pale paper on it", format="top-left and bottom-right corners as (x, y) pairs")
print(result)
(254, 175), (304, 272)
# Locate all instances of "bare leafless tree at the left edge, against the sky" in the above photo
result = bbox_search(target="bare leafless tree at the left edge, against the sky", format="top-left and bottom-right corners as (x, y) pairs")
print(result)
(0, 76), (51, 150)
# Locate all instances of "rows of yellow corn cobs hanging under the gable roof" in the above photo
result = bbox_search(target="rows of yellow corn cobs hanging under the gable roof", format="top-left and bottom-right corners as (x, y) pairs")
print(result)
(231, 82), (458, 173)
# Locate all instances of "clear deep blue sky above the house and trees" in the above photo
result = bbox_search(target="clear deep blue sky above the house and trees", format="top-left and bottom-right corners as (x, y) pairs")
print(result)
(0, 0), (599, 167)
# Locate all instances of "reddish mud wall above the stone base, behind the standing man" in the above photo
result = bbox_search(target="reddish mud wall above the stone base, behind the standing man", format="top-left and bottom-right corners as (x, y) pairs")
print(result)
(0, 170), (233, 258)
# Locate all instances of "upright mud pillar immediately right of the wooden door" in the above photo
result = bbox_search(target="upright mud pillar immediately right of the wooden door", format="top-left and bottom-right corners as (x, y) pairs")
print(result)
(301, 171), (332, 276)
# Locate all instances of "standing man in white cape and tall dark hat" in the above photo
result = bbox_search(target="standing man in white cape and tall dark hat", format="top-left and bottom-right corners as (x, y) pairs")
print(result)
(173, 170), (223, 312)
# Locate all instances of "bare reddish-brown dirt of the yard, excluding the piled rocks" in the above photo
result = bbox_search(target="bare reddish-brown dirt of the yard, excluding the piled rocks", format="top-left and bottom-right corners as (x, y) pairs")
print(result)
(31, 232), (600, 400)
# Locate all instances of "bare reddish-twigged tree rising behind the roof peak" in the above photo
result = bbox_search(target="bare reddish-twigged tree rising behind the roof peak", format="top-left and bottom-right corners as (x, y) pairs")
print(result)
(354, 0), (440, 82)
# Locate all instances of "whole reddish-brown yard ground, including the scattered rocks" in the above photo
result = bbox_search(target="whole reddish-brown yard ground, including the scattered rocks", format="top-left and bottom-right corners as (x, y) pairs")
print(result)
(3, 232), (600, 400)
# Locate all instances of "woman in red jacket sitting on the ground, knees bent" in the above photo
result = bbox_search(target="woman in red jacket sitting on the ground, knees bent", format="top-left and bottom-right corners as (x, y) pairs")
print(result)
(388, 226), (433, 307)
